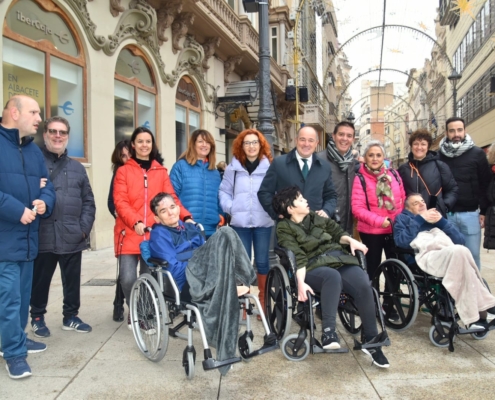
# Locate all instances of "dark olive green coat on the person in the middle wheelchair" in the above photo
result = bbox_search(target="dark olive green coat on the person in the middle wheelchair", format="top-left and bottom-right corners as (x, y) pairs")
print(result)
(277, 211), (359, 271)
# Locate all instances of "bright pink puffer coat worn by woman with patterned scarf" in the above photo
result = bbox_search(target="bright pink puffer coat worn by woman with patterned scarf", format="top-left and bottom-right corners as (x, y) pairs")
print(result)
(351, 165), (406, 234)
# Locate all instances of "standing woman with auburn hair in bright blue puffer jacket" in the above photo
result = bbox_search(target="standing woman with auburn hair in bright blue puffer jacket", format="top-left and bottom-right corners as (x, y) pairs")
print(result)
(170, 129), (221, 238)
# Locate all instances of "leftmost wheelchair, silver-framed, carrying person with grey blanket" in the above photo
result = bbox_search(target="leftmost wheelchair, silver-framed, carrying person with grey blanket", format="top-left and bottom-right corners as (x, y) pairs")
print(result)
(129, 252), (279, 379)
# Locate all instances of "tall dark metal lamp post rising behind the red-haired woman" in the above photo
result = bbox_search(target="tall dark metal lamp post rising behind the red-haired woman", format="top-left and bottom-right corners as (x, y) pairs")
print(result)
(258, 1), (278, 268)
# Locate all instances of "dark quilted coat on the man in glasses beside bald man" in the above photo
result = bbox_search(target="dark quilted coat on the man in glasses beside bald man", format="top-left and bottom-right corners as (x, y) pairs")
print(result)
(39, 148), (96, 254)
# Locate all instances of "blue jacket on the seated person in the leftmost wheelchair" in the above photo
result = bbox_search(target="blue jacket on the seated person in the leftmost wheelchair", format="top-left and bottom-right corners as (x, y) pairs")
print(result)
(149, 221), (205, 290)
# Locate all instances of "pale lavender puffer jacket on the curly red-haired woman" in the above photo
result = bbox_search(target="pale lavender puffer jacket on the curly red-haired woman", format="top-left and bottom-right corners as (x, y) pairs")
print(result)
(218, 157), (273, 228)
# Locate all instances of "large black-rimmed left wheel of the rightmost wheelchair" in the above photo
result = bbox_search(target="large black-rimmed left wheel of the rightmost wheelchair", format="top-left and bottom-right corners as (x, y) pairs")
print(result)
(372, 259), (419, 332)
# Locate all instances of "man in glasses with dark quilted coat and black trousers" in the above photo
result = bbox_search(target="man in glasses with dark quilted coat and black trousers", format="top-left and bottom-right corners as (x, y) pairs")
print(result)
(31, 117), (96, 337)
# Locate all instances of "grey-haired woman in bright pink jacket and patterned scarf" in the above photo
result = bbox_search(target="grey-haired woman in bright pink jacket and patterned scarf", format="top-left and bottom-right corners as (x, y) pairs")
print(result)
(351, 140), (406, 279)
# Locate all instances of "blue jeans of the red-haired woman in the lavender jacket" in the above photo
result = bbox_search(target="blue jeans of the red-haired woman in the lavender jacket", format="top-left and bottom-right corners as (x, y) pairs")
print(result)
(231, 226), (273, 275)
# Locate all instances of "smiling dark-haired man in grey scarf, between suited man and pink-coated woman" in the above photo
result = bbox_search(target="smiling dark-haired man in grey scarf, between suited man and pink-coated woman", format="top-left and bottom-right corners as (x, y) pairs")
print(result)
(317, 121), (359, 235)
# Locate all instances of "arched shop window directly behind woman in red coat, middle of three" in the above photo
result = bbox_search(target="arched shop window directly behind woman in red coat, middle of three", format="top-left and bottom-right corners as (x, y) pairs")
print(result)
(114, 47), (158, 143)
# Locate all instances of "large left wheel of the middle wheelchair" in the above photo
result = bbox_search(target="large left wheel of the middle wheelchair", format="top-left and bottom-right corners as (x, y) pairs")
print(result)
(265, 265), (292, 340)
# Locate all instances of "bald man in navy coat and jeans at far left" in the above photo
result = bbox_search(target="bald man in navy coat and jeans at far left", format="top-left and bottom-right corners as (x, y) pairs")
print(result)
(0, 96), (55, 379)
